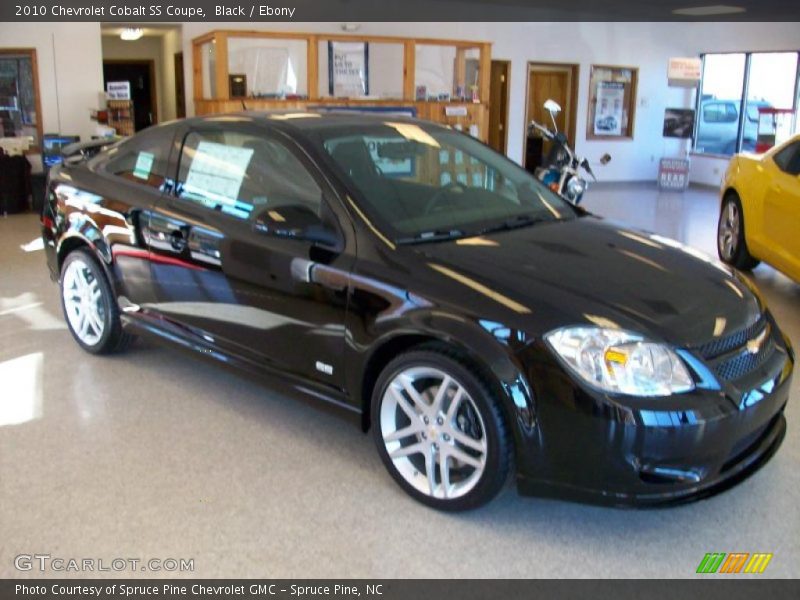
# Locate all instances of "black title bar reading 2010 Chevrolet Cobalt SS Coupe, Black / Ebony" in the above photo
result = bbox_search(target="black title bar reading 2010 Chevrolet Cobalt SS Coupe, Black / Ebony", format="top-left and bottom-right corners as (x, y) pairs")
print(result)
(0, 0), (800, 22)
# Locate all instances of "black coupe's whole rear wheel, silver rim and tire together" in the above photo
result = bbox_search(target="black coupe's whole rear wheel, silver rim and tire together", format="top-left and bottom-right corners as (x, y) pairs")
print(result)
(61, 249), (133, 354)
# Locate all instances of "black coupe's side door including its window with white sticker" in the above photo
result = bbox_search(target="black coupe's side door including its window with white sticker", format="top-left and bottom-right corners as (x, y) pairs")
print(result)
(151, 124), (354, 387)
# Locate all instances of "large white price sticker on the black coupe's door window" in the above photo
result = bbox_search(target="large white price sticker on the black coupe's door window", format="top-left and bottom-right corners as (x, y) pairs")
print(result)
(183, 141), (253, 209)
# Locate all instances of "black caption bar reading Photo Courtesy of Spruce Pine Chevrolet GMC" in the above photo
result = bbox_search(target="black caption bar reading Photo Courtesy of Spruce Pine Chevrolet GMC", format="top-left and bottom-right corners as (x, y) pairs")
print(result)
(0, 575), (800, 600)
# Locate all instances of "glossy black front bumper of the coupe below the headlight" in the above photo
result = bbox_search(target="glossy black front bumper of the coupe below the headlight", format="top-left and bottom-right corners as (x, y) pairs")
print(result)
(517, 314), (794, 507)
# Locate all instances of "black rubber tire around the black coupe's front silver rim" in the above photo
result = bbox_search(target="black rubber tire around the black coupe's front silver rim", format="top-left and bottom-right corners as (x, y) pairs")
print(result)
(371, 344), (513, 512)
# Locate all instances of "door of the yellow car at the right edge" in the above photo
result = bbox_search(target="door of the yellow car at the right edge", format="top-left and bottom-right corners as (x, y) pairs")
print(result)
(763, 141), (800, 279)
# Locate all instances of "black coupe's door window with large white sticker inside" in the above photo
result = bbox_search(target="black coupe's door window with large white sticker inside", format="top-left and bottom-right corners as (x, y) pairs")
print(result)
(176, 131), (322, 220)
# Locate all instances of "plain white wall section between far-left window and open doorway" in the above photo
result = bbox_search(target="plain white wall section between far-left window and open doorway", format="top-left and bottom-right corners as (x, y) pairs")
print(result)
(0, 22), (103, 170)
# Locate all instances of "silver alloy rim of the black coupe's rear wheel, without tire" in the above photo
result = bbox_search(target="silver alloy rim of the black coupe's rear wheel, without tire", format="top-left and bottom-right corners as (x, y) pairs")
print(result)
(61, 258), (106, 346)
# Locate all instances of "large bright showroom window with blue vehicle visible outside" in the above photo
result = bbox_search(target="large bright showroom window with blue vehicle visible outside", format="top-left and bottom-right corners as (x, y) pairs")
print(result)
(695, 52), (798, 156)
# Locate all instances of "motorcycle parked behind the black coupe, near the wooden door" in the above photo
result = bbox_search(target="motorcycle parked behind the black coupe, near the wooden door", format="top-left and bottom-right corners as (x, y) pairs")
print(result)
(528, 100), (611, 206)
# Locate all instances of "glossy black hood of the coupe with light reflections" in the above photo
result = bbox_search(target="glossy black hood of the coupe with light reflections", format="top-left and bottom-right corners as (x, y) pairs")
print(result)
(415, 216), (763, 345)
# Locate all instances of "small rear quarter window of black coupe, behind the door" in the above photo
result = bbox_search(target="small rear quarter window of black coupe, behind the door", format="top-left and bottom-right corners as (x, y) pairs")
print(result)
(104, 131), (172, 191)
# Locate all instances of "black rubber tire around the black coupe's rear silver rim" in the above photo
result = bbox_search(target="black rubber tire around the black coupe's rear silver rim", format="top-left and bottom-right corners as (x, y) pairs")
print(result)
(59, 248), (136, 354)
